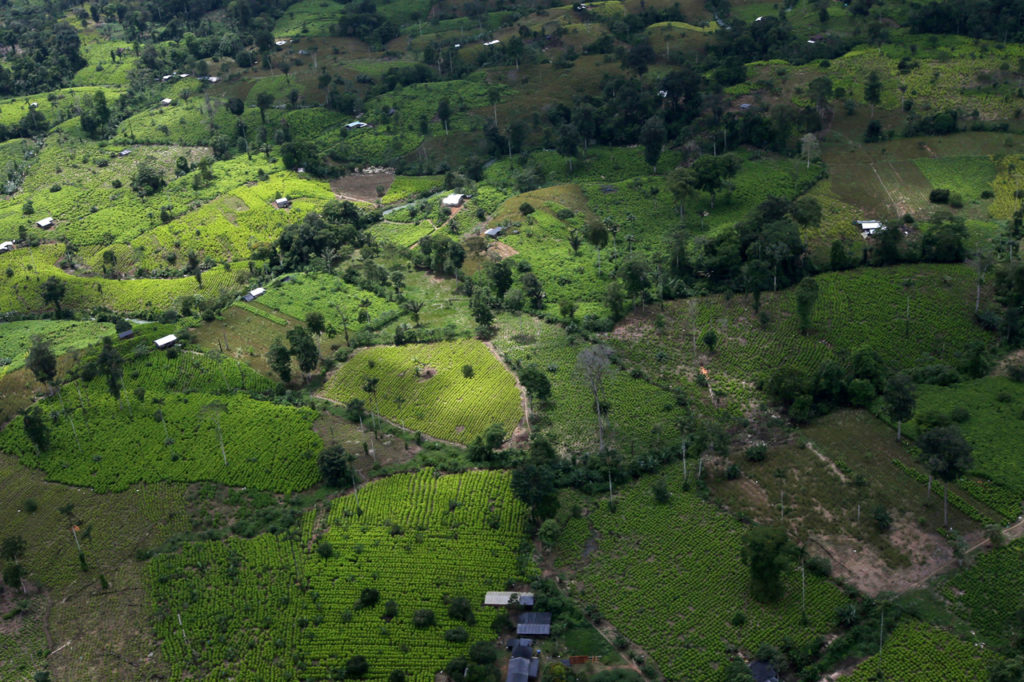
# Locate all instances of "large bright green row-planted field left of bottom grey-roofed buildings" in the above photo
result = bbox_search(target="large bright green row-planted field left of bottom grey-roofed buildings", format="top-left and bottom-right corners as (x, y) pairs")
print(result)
(150, 469), (526, 682)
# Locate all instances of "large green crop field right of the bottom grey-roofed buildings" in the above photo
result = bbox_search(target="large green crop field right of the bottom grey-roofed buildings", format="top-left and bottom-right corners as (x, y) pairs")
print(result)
(556, 463), (845, 680)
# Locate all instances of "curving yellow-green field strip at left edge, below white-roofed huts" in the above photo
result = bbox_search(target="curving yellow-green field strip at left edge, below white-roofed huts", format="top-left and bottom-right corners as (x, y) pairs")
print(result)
(0, 244), (246, 314)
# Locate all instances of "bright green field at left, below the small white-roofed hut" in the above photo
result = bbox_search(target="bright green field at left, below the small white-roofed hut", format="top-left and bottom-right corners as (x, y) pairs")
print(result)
(0, 350), (323, 492)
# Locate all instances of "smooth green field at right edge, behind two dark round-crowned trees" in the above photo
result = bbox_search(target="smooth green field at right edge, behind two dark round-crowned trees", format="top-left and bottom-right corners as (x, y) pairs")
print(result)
(904, 377), (1024, 493)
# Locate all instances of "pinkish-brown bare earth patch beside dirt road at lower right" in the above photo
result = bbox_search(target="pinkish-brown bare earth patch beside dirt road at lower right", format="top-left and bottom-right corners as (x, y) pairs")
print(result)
(812, 517), (953, 597)
